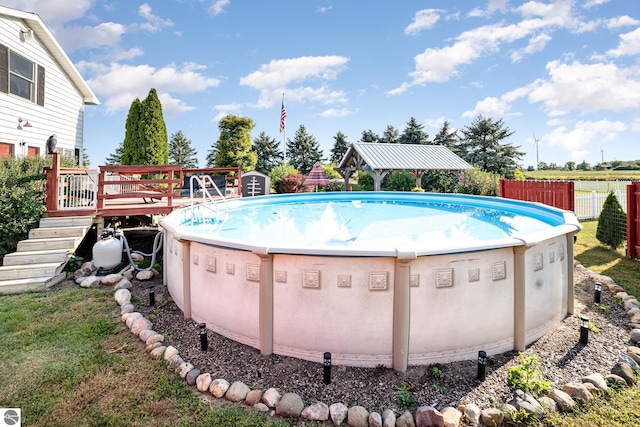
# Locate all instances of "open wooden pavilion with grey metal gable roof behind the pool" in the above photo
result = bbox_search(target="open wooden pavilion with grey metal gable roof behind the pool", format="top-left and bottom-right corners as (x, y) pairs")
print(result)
(336, 142), (472, 191)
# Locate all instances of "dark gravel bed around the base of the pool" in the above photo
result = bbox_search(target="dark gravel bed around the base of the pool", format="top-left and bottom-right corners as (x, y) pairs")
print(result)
(119, 265), (630, 414)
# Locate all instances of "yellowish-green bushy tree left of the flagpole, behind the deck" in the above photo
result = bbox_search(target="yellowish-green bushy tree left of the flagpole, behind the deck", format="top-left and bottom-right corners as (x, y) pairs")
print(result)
(216, 114), (258, 171)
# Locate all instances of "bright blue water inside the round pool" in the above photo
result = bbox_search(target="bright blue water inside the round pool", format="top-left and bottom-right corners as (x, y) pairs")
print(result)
(180, 192), (565, 254)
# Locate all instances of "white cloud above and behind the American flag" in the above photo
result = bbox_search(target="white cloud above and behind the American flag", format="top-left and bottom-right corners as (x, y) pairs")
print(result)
(240, 55), (349, 108)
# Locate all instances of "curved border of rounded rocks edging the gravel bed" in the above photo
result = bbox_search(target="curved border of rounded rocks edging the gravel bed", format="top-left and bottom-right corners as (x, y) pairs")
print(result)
(110, 263), (640, 427)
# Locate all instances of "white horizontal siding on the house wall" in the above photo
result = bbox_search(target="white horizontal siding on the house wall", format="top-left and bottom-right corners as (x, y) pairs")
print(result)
(0, 14), (84, 160)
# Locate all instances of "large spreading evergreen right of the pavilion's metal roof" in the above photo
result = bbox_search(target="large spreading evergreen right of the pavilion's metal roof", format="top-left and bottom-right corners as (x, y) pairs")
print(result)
(455, 116), (524, 179)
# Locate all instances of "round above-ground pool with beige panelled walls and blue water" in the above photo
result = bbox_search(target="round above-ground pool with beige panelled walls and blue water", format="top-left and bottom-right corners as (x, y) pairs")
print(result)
(160, 192), (580, 370)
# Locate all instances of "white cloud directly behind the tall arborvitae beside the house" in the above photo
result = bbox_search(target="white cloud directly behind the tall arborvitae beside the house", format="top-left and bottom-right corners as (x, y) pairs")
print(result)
(81, 63), (220, 114)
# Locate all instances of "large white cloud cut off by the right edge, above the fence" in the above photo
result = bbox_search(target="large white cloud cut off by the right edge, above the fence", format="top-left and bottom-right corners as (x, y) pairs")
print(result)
(529, 61), (640, 115)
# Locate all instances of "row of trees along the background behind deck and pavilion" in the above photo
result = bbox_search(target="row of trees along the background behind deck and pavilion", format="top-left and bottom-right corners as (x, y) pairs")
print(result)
(107, 89), (524, 182)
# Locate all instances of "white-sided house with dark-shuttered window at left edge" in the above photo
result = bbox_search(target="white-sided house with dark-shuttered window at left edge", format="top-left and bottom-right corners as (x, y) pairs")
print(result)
(0, 6), (99, 163)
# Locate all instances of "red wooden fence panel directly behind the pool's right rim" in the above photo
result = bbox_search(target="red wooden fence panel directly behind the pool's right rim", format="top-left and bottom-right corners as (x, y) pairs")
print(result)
(500, 179), (575, 211)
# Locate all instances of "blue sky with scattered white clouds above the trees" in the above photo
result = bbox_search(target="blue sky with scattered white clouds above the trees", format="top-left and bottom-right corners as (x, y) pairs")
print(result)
(2, 0), (640, 167)
